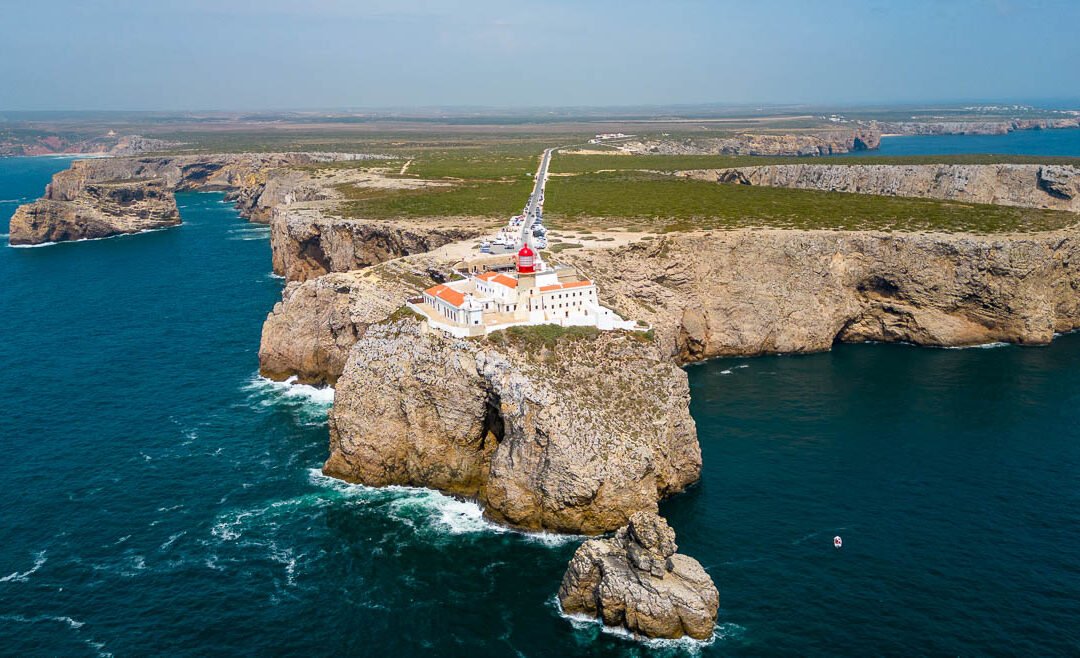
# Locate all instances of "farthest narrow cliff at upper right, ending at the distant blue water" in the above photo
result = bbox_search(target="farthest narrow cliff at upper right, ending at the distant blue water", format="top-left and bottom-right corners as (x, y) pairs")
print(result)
(620, 125), (881, 156)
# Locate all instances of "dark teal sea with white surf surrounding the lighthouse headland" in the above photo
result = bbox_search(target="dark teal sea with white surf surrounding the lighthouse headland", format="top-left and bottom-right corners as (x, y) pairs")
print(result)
(0, 149), (1080, 656)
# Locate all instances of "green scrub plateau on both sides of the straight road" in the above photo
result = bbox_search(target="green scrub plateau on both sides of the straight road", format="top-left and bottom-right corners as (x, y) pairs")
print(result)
(287, 135), (1080, 233)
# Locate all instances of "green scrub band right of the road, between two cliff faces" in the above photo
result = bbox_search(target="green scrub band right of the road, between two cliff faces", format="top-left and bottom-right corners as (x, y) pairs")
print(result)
(545, 172), (1077, 233)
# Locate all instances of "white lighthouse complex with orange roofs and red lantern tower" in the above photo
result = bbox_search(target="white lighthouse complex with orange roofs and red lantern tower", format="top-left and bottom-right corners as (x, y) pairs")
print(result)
(409, 245), (636, 336)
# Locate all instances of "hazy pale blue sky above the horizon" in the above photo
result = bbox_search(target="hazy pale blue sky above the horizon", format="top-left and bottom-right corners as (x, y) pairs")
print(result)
(0, 0), (1080, 110)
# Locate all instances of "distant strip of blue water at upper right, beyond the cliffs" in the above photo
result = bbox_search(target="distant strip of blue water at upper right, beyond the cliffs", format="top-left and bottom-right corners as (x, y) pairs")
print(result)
(864, 129), (1080, 158)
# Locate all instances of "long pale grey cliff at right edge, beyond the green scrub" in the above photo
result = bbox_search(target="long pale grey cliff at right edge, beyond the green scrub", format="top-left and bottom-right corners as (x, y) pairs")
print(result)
(677, 164), (1080, 212)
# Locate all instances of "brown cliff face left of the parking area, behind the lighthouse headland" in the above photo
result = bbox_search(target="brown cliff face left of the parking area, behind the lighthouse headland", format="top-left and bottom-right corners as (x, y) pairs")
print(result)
(270, 209), (484, 281)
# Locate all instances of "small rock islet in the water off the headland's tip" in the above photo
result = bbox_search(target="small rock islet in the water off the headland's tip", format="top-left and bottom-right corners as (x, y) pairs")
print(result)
(558, 512), (720, 640)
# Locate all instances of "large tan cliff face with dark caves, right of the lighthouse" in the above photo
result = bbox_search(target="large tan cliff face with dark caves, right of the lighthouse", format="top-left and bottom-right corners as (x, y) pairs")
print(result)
(565, 230), (1080, 362)
